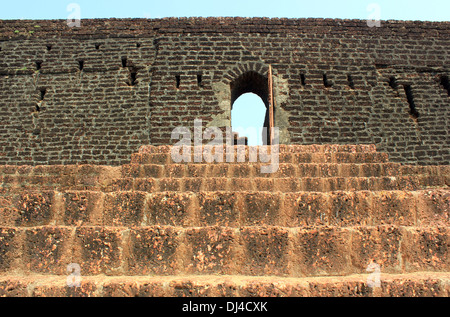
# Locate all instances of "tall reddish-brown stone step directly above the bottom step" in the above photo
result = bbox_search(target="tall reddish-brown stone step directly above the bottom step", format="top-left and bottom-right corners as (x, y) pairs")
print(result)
(0, 225), (450, 277)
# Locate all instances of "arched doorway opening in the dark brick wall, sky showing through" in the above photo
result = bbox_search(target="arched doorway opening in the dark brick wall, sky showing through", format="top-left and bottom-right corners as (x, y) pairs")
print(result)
(230, 71), (269, 145)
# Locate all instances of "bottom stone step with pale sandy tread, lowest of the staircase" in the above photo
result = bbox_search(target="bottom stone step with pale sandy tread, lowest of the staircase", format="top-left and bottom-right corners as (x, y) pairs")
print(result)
(0, 272), (450, 297)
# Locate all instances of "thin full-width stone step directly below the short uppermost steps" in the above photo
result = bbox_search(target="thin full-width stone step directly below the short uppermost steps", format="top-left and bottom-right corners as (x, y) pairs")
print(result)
(0, 162), (450, 179)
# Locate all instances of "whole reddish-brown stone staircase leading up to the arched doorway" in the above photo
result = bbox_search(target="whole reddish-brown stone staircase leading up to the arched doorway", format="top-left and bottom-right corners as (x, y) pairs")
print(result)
(0, 145), (450, 297)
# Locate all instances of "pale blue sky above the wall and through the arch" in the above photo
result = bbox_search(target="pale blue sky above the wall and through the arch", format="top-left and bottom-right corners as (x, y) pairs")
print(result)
(0, 0), (450, 145)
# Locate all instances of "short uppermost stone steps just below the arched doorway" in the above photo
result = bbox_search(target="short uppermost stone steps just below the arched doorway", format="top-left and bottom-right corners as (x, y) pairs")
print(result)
(131, 144), (389, 165)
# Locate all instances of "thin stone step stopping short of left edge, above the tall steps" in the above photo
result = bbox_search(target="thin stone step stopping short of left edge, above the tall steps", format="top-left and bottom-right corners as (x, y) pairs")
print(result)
(107, 175), (448, 192)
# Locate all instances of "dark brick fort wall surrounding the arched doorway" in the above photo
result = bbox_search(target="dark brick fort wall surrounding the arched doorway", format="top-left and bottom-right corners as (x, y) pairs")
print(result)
(0, 18), (450, 165)
